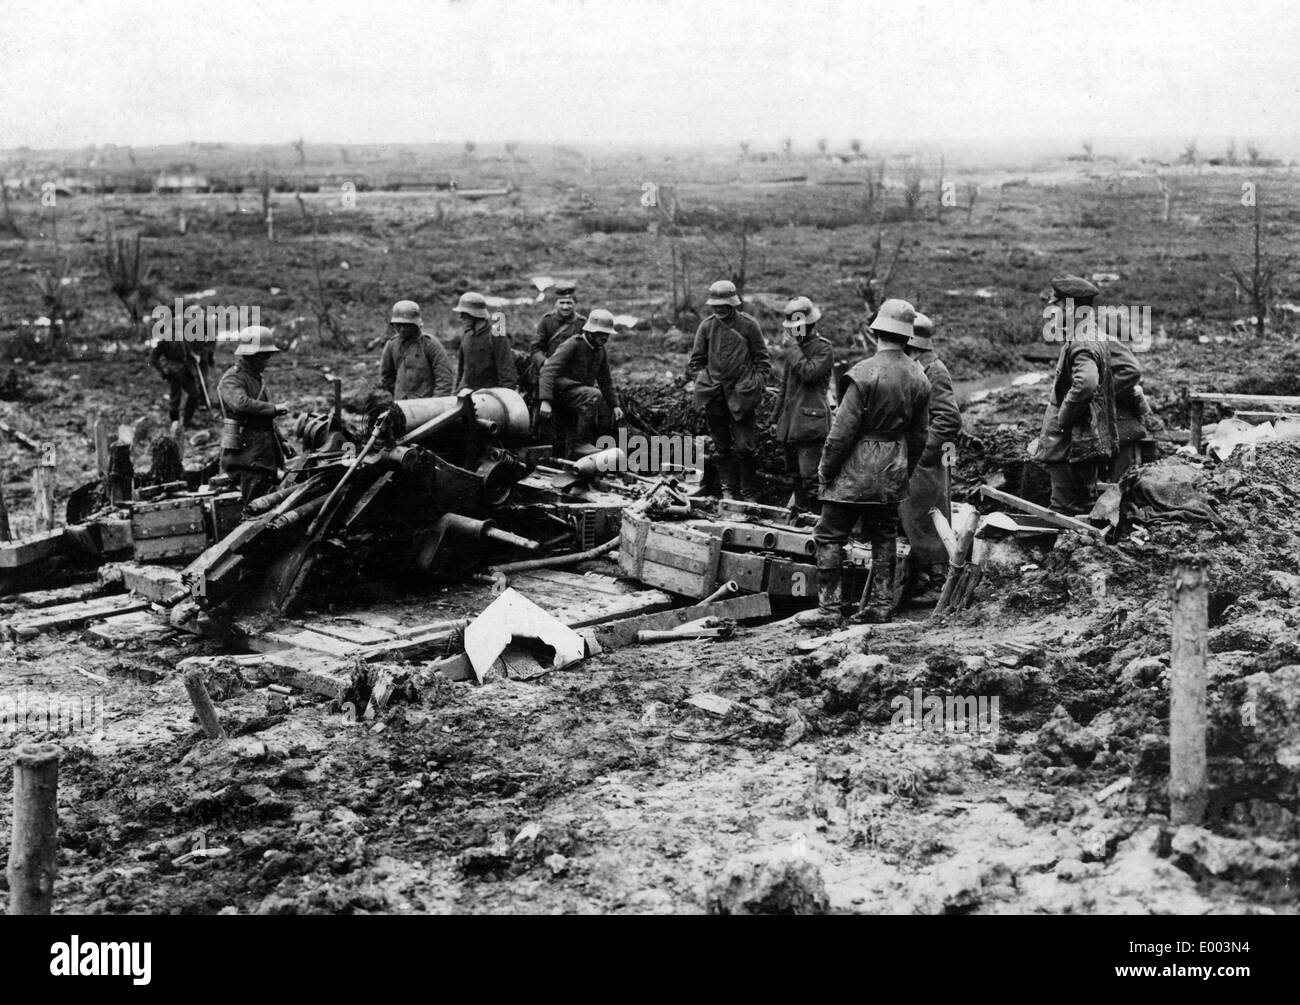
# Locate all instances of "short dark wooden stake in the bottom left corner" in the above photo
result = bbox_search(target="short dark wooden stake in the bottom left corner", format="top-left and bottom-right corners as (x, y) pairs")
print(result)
(9, 744), (59, 914)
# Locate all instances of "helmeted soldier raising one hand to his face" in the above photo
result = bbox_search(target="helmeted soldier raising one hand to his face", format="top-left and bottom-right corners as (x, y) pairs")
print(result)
(772, 296), (835, 510)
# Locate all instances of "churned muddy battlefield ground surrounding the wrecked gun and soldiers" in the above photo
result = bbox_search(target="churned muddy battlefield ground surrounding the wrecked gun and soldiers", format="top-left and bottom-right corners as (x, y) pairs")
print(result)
(0, 146), (1300, 914)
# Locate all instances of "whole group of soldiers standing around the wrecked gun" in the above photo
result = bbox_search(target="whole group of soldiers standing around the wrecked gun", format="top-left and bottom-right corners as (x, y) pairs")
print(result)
(173, 266), (1158, 624)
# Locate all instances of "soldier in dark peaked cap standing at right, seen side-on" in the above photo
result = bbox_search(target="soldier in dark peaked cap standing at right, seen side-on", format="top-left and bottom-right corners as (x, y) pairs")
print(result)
(1034, 276), (1119, 516)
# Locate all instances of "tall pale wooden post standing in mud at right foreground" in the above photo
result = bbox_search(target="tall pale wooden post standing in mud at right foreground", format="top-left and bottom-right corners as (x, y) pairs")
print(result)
(1169, 555), (1209, 826)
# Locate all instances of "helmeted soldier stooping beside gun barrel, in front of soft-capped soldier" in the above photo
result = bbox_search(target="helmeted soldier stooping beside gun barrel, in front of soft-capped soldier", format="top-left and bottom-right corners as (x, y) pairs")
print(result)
(538, 309), (623, 455)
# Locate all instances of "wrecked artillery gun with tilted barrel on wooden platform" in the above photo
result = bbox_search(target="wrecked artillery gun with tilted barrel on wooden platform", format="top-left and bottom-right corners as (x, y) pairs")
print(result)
(182, 387), (551, 614)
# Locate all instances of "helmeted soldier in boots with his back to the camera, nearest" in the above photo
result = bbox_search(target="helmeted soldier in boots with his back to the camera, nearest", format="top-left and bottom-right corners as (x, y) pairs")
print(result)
(796, 300), (930, 625)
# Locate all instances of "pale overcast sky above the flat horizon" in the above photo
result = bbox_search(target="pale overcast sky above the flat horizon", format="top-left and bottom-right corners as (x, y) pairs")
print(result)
(0, 0), (1300, 148)
